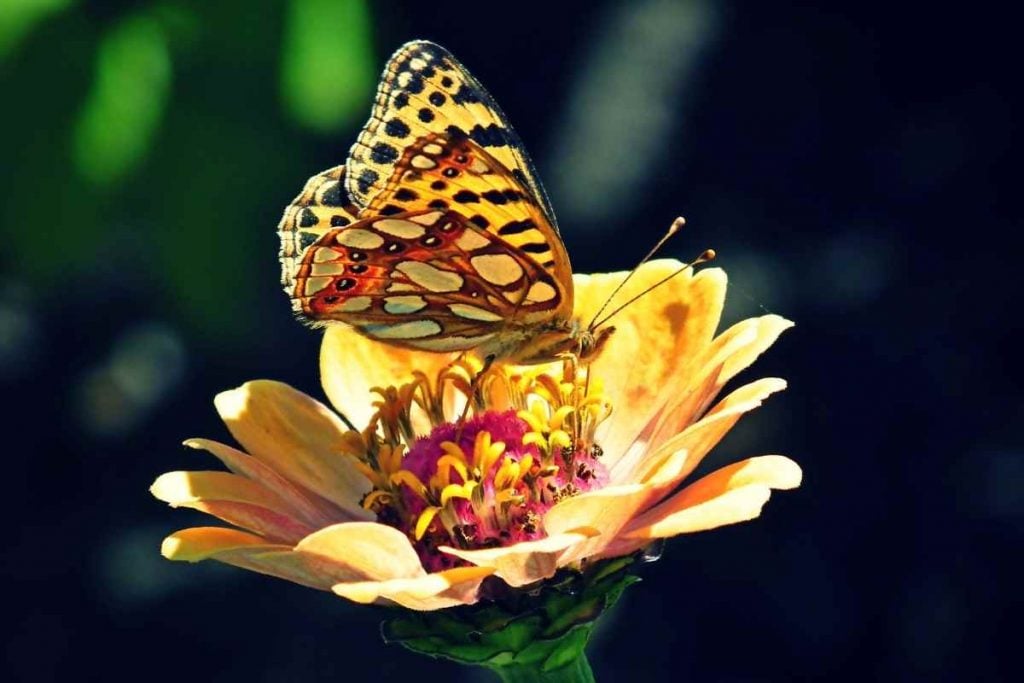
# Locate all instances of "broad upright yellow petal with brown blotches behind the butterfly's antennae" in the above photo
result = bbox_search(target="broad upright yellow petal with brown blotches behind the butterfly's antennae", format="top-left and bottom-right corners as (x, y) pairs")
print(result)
(574, 259), (726, 465)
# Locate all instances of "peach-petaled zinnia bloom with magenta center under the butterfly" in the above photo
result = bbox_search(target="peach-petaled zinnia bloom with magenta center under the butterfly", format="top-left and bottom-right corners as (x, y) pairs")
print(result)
(152, 259), (801, 663)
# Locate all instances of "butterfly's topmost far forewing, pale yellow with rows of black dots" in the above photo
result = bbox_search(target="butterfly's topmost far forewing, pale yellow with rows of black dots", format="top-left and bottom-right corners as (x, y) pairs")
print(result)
(346, 41), (557, 236)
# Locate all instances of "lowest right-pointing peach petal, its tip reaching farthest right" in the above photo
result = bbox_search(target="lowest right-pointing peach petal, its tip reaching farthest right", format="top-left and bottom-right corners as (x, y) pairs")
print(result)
(626, 456), (803, 540)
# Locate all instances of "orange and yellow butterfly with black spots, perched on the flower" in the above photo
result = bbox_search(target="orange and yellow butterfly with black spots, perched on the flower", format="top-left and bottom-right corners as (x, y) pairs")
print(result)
(278, 41), (612, 364)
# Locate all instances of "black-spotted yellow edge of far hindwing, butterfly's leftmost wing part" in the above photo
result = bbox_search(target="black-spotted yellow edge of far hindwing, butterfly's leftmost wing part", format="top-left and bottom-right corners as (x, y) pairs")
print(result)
(278, 166), (358, 301)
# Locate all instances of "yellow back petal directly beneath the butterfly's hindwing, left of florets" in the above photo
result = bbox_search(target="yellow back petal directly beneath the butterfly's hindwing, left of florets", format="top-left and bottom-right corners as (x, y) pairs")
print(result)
(321, 325), (457, 429)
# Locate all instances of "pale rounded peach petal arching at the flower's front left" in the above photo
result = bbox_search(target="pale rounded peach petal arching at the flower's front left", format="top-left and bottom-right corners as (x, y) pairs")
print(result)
(295, 522), (424, 581)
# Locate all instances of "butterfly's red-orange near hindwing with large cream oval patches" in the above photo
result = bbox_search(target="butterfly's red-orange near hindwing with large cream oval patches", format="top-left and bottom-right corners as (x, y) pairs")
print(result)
(284, 210), (562, 351)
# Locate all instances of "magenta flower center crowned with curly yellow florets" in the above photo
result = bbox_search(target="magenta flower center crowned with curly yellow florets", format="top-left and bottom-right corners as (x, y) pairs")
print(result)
(348, 359), (611, 570)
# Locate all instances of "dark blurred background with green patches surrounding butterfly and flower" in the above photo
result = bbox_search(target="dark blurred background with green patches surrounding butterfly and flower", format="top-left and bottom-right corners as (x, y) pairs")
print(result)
(0, 0), (1024, 682)
